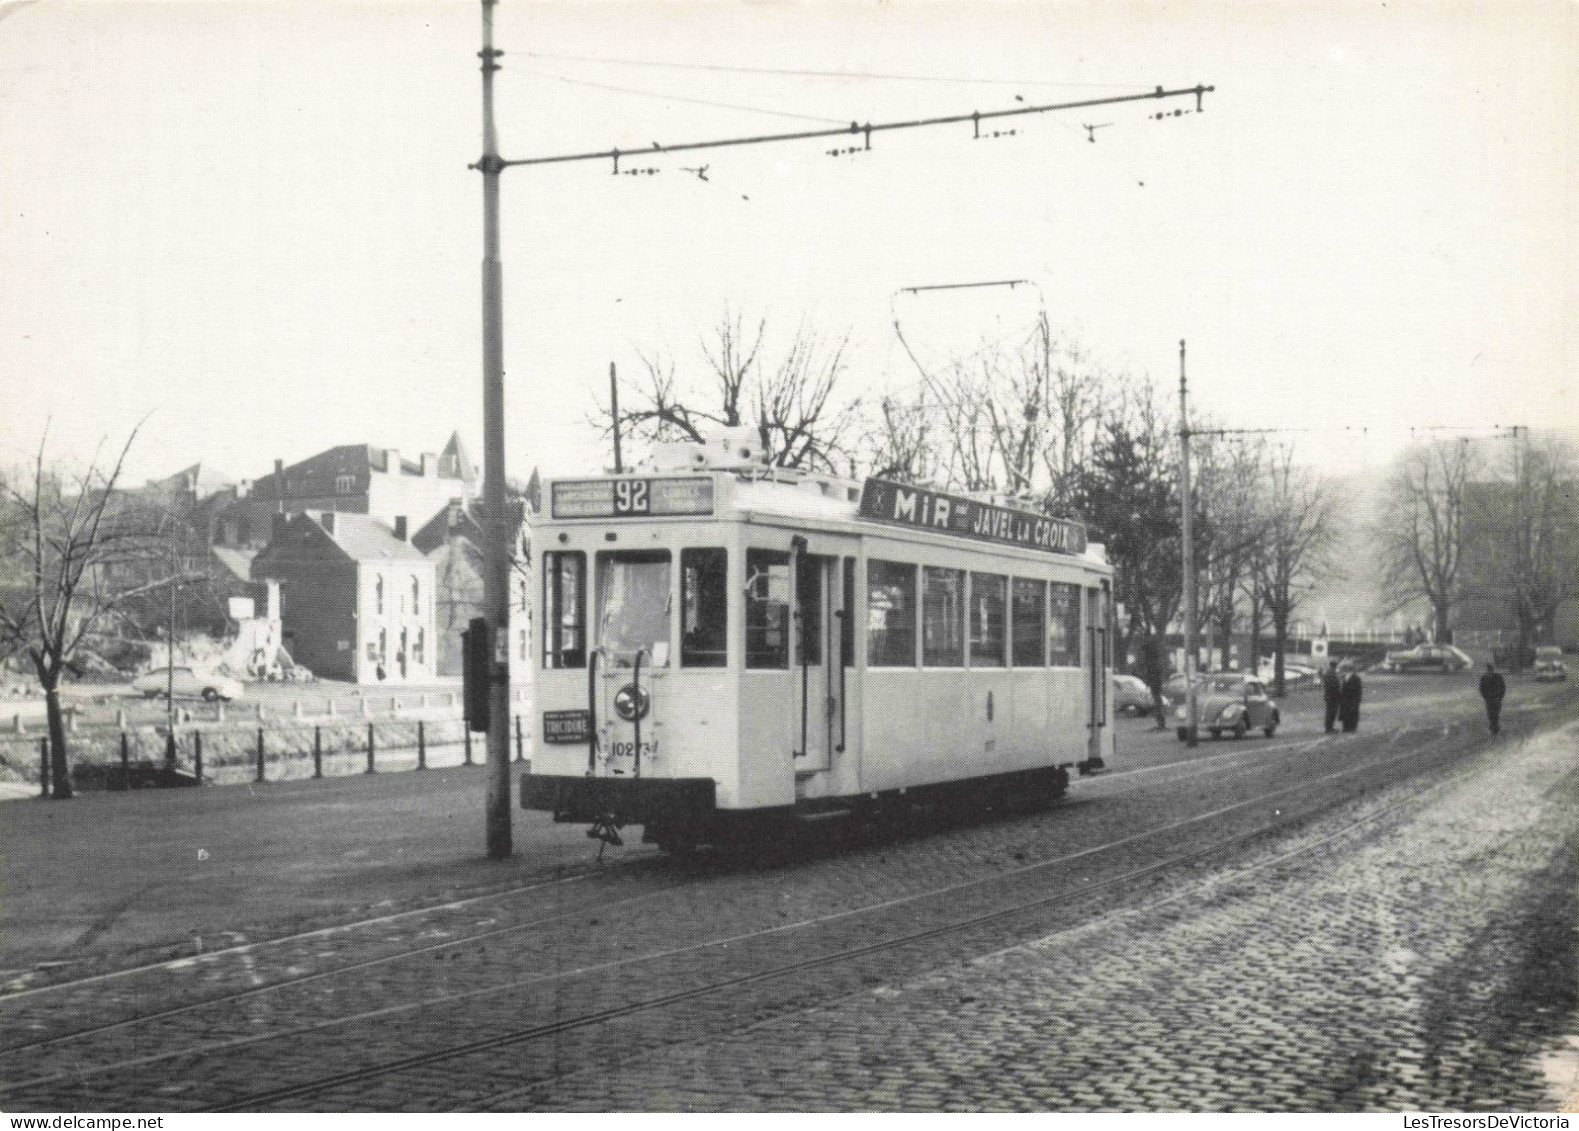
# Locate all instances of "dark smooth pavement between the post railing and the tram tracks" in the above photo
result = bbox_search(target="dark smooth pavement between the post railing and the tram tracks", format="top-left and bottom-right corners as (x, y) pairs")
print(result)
(0, 766), (654, 986)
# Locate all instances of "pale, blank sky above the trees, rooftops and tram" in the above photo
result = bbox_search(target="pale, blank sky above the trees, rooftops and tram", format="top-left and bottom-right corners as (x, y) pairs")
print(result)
(0, 0), (1579, 480)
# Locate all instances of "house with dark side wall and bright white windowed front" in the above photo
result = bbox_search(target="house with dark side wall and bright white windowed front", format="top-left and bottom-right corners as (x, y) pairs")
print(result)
(253, 510), (439, 684)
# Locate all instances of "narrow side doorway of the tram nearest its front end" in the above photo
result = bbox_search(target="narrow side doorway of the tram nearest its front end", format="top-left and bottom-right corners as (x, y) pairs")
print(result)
(790, 553), (840, 774)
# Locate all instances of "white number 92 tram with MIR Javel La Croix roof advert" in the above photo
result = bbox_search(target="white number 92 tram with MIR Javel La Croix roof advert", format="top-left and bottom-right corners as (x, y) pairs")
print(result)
(521, 431), (1113, 850)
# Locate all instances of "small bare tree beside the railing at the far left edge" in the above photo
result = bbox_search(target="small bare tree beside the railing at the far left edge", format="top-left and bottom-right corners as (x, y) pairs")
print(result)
(0, 430), (186, 799)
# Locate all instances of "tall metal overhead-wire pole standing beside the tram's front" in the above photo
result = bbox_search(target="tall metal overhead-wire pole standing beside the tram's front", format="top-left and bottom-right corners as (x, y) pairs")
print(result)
(475, 0), (513, 859)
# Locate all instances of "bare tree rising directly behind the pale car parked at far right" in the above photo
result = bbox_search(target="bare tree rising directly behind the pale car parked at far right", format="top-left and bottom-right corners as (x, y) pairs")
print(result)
(1375, 439), (1475, 644)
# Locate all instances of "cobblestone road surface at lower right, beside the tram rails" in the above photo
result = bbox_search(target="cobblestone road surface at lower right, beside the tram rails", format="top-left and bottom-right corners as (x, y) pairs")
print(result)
(521, 727), (1579, 1110)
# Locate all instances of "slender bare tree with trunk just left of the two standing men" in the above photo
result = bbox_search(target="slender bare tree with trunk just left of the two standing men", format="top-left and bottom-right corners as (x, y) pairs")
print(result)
(1258, 449), (1339, 695)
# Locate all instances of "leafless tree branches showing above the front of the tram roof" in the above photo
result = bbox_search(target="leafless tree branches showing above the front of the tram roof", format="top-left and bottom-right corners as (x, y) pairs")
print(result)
(597, 311), (859, 471)
